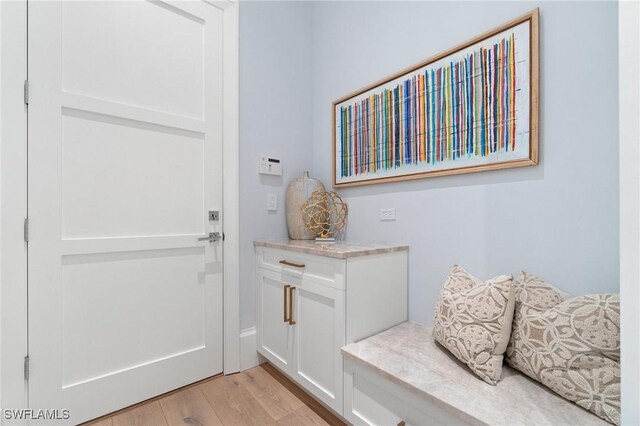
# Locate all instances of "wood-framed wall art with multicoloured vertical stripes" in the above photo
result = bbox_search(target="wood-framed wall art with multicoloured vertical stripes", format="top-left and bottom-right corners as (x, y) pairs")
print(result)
(332, 9), (539, 187)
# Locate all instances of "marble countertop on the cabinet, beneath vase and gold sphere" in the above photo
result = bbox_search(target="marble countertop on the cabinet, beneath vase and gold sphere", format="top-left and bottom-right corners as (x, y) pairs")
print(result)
(253, 240), (409, 259)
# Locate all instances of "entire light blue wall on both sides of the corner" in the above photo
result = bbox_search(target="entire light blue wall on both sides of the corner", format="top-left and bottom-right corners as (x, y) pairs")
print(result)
(240, 1), (619, 328)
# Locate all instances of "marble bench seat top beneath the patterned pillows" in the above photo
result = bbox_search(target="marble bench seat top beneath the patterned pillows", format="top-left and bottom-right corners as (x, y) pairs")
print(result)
(342, 322), (609, 425)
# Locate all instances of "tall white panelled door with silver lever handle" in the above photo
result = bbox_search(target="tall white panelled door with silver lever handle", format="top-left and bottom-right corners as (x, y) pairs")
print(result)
(28, 1), (223, 424)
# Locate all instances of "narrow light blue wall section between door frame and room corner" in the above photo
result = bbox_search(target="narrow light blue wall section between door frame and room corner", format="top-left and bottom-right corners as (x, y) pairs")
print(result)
(240, 1), (313, 328)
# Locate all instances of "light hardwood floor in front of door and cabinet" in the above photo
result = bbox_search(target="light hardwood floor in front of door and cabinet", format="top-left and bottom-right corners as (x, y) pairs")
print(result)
(83, 364), (344, 426)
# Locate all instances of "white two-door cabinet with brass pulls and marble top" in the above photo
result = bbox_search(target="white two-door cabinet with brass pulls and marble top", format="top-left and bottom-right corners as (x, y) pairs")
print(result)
(256, 242), (407, 415)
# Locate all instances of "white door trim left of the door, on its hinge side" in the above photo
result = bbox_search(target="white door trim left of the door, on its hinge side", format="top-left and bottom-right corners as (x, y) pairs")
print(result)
(0, 0), (28, 416)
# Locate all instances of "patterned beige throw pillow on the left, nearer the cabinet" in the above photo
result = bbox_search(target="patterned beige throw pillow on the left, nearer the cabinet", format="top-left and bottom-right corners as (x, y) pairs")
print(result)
(433, 265), (514, 385)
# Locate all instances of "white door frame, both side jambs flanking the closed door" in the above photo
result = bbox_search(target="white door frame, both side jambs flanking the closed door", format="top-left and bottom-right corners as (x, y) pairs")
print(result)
(0, 0), (240, 414)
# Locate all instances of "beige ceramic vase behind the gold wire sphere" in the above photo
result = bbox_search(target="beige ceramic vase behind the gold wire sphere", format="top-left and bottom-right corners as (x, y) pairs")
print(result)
(285, 172), (324, 240)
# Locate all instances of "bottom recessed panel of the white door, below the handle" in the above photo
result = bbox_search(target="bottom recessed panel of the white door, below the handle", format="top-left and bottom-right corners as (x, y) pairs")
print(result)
(62, 247), (205, 387)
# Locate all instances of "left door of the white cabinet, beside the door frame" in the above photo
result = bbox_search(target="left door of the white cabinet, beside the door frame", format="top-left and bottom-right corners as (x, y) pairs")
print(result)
(256, 268), (300, 373)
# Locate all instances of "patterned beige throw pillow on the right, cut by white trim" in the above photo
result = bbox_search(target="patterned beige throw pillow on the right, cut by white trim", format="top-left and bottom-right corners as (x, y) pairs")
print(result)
(507, 272), (620, 425)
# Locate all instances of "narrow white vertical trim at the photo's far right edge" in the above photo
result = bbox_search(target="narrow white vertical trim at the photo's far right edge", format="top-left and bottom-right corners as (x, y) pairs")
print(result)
(618, 1), (640, 425)
